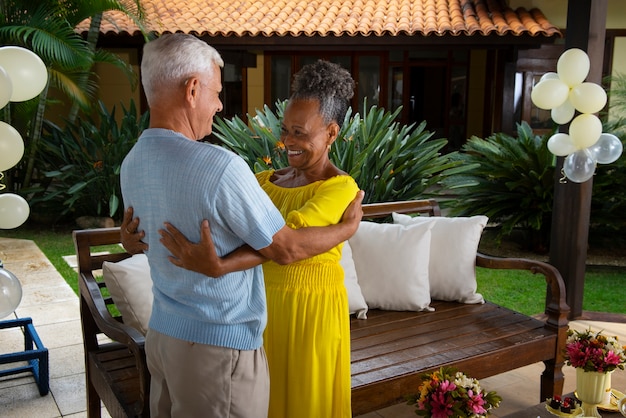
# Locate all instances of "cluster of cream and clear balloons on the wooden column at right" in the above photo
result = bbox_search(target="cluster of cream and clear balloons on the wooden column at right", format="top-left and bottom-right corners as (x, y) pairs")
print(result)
(530, 48), (623, 183)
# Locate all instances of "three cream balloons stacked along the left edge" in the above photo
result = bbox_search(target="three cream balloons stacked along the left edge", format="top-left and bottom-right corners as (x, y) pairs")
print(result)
(0, 46), (48, 229)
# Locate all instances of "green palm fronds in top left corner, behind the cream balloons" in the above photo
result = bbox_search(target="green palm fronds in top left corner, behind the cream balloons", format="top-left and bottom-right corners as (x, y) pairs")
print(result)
(0, 0), (148, 188)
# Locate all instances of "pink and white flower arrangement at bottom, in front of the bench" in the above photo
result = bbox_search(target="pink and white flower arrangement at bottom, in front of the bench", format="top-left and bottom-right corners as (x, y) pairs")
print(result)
(407, 367), (502, 418)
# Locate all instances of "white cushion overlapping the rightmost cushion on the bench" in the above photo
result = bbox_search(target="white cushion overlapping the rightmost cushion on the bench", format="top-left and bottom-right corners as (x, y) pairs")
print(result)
(348, 221), (432, 311)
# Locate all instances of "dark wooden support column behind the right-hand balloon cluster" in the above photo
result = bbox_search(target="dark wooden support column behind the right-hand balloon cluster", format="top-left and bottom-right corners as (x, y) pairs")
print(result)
(550, 0), (608, 319)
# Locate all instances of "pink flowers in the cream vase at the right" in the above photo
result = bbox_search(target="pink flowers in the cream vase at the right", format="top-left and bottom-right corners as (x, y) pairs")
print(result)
(565, 328), (626, 373)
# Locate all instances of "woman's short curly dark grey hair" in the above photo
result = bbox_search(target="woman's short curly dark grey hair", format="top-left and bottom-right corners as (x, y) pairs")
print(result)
(290, 60), (355, 126)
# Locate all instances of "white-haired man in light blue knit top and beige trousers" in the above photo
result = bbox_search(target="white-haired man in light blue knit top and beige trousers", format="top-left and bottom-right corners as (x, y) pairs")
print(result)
(121, 34), (363, 418)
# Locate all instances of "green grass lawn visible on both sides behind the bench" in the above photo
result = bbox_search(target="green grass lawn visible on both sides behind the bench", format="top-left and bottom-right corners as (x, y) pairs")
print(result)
(0, 225), (626, 315)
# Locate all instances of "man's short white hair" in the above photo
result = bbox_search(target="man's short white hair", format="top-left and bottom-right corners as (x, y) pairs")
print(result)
(141, 33), (224, 105)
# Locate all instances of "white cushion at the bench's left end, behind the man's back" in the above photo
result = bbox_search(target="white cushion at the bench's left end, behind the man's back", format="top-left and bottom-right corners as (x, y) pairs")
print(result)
(102, 254), (152, 335)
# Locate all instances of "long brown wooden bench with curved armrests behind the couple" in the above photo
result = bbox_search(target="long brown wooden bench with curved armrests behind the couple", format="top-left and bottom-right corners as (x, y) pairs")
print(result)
(73, 200), (569, 417)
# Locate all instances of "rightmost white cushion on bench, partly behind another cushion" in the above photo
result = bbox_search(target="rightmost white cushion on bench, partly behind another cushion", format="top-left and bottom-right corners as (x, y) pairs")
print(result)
(392, 213), (489, 303)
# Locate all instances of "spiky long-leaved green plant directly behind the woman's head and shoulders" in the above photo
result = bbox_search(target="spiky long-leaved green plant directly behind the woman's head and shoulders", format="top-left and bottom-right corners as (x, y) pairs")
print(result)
(215, 102), (467, 203)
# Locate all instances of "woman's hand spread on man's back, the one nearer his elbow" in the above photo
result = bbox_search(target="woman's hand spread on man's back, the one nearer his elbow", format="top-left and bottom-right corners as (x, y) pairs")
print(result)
(159, 220), (228, 277)
